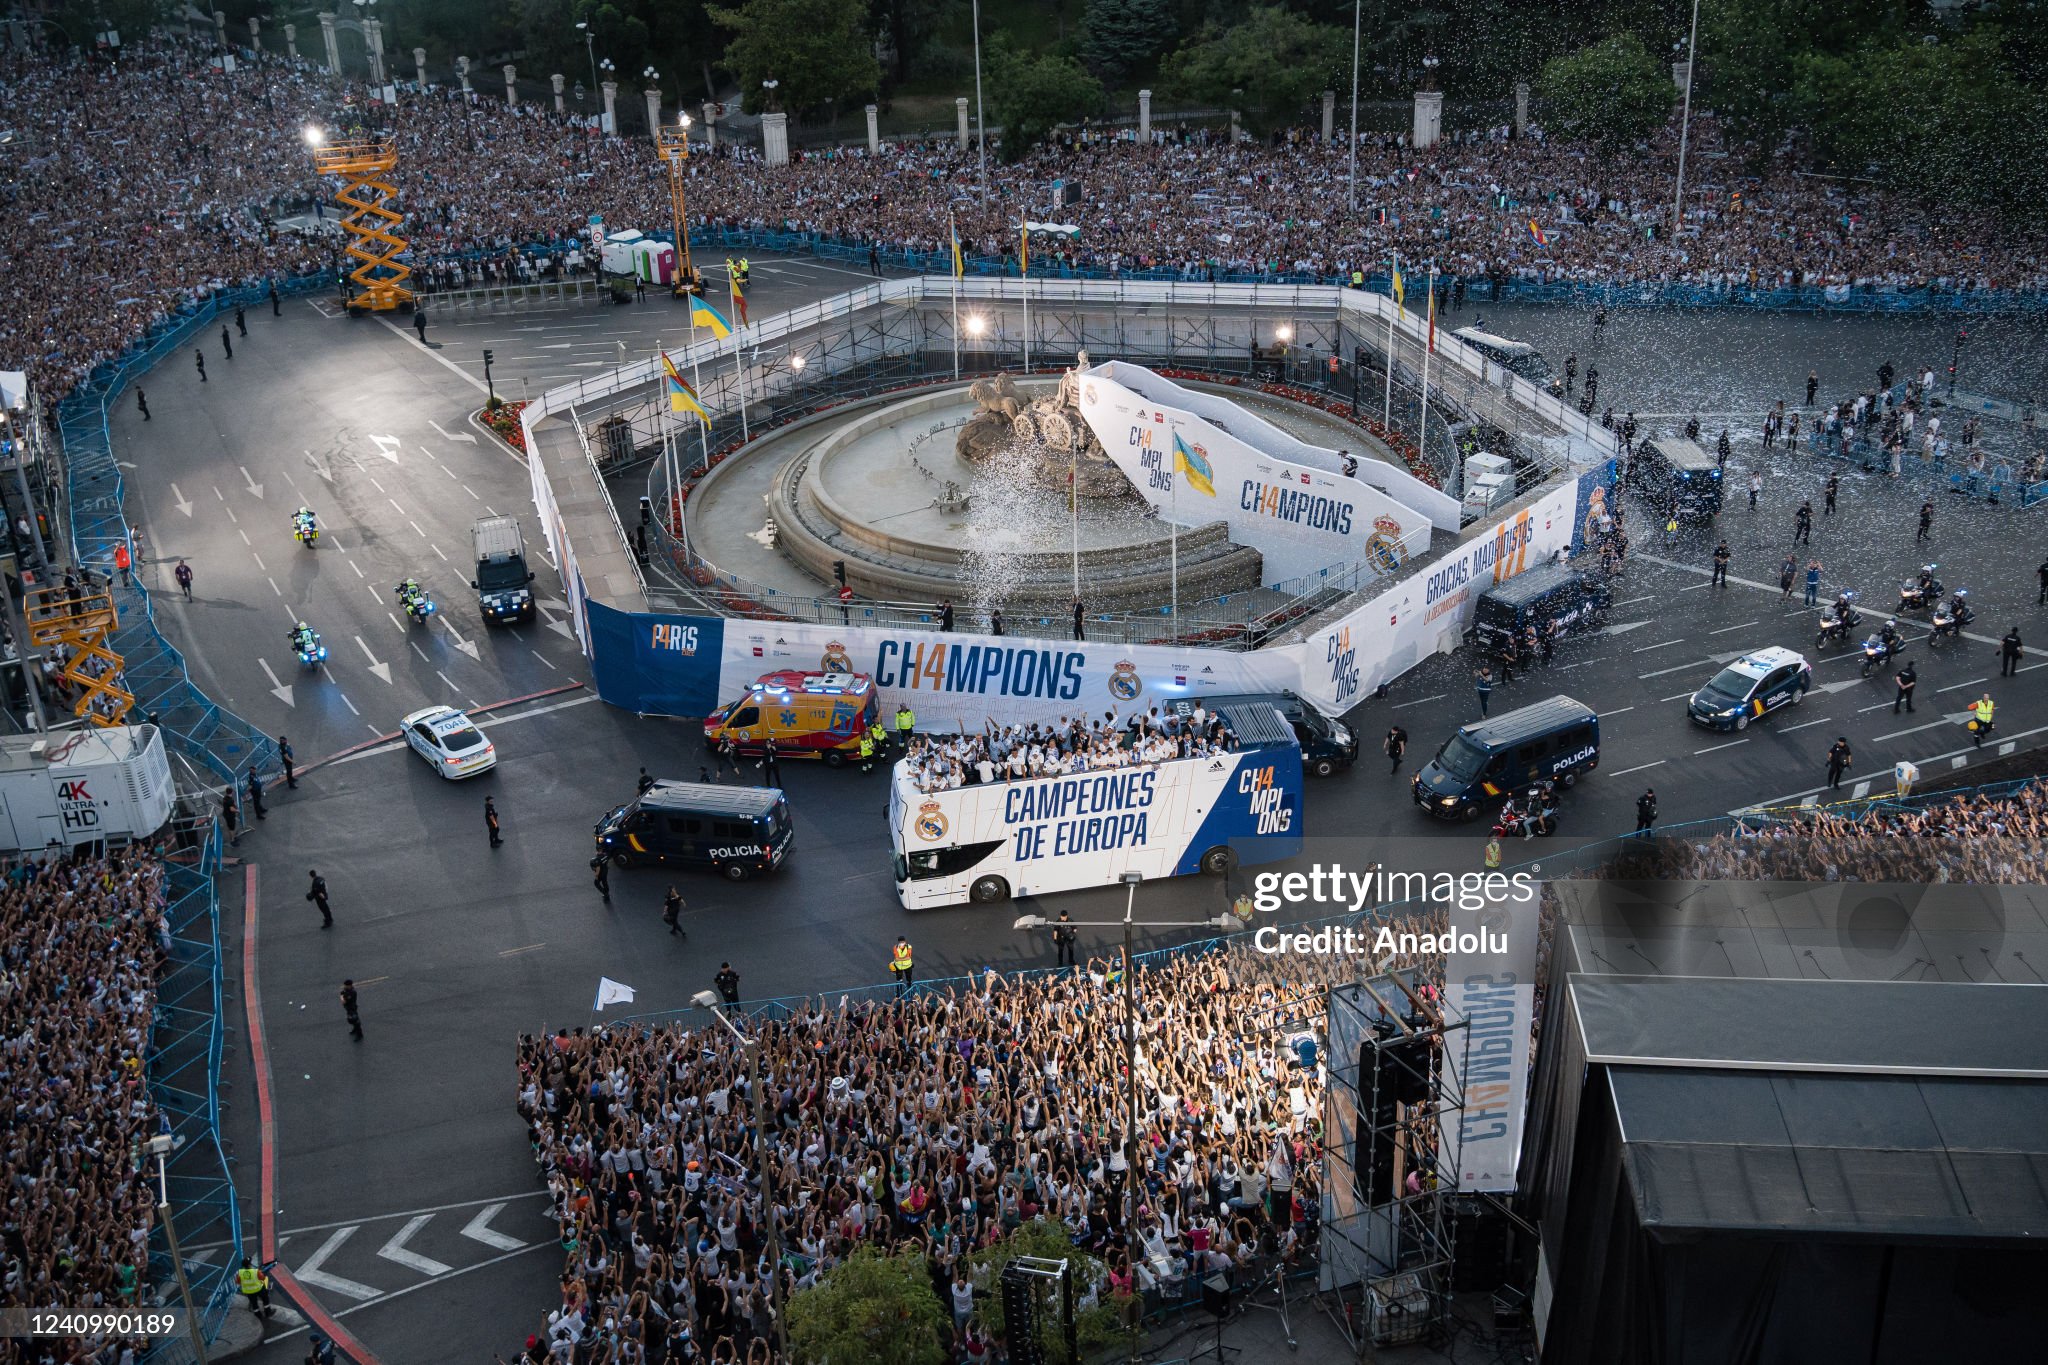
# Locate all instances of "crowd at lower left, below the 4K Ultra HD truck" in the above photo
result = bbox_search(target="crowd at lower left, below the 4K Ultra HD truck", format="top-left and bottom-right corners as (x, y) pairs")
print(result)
(0, 849), (172, 1361)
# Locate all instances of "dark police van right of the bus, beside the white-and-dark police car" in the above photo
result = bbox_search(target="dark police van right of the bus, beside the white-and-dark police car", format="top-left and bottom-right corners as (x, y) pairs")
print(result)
(1409, 696), (1599, 821)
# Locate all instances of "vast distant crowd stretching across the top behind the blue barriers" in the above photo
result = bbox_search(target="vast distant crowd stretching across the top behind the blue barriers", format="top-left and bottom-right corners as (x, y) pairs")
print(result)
(0, 39), (2048, 409)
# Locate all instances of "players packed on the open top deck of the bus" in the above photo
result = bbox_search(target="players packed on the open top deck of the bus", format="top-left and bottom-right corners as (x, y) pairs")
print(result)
(905, 706), (1237, 792)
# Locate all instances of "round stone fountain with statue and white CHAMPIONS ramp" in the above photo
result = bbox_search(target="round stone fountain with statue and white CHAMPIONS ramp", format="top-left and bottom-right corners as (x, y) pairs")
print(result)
(720, 352), (1458, 626)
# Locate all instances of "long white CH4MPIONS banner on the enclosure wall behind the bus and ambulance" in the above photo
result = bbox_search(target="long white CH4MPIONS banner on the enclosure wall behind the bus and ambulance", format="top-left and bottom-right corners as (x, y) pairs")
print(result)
(719, 620), (1300, 733)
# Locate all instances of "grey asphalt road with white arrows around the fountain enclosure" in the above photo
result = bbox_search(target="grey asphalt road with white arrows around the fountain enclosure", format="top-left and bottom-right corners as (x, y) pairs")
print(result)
(115, 262), (2048, 1365)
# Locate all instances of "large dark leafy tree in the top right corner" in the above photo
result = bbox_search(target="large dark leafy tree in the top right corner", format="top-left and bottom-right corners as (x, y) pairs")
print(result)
(1790, 29), (2048, 207)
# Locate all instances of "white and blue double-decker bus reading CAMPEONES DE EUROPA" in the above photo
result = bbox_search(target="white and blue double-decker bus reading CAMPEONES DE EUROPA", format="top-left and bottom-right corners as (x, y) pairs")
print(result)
(889, 706), (1303, 911)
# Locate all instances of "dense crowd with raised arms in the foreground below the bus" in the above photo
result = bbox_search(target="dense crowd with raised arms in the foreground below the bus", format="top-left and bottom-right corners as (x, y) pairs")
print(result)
(518, 945), (1392, 1363)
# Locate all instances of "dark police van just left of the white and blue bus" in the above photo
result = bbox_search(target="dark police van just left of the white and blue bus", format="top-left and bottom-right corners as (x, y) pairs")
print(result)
(596, 782), (797, 882)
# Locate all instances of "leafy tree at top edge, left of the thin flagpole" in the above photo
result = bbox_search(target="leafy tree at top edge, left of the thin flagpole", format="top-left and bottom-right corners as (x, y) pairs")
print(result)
(705, 0), (883, 113)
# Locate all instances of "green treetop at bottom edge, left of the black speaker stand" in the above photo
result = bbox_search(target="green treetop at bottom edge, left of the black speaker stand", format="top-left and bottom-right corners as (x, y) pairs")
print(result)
(788, 1246), (952, 1365)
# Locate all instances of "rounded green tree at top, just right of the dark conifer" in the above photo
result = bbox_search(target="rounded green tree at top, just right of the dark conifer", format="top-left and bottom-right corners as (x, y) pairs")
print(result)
(1163, 6), (1352, 131)
